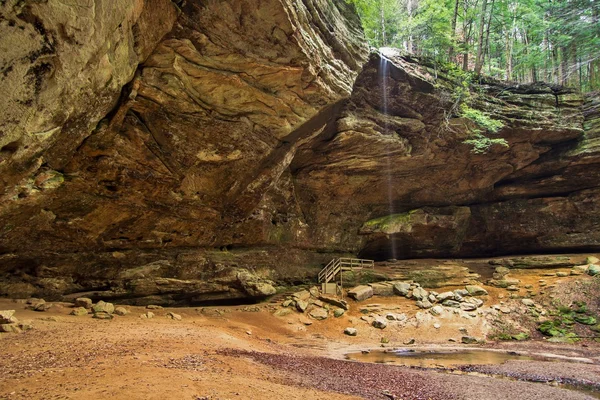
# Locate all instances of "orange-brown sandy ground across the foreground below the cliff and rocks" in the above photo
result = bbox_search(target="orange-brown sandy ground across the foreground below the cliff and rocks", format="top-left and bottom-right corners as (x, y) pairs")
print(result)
(0, 298), (600, 400)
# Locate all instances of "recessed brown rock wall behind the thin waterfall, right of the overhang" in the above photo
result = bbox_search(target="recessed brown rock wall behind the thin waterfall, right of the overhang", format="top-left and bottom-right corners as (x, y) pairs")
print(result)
(292, 52), (600, 260)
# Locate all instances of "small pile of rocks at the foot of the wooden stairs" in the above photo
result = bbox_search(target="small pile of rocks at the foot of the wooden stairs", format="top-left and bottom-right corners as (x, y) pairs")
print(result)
(275, 287), (350, 320)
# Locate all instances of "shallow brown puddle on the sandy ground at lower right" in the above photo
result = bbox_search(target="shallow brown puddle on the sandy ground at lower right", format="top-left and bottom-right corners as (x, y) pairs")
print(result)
(346, 349), (543, 368)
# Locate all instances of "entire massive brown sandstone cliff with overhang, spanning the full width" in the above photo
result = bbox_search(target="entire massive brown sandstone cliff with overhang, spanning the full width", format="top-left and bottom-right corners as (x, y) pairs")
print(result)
(0, 0), (600, 303)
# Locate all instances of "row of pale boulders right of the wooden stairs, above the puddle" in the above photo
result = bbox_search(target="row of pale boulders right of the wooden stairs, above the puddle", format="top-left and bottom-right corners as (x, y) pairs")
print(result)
(348, 282), (488, 311)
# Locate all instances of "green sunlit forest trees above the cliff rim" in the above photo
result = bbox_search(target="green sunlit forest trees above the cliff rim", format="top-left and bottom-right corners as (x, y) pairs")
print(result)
(347, 0), (600, 92)
